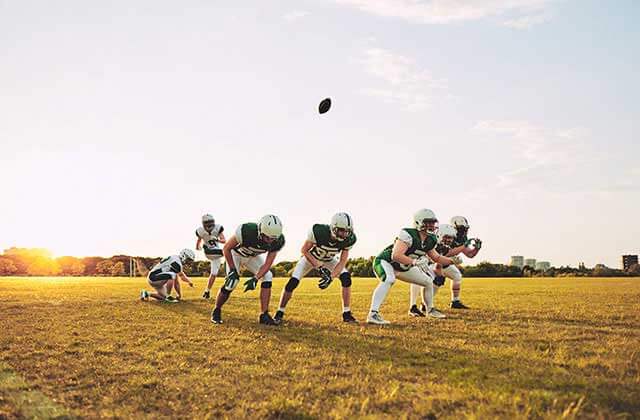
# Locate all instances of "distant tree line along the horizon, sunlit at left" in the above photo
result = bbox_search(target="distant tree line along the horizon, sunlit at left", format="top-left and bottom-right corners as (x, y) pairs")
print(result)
(0, 248), (640, 277)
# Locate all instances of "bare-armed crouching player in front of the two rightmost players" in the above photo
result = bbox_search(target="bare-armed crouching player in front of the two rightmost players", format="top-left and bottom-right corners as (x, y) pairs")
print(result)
(367, 209), (453, 325)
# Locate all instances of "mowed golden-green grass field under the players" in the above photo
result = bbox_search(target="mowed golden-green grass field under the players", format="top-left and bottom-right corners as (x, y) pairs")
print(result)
(0, 278), (640, 419)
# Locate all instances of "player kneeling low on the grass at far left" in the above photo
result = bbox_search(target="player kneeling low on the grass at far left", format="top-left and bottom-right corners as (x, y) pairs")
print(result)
(140, 249), (196, 302)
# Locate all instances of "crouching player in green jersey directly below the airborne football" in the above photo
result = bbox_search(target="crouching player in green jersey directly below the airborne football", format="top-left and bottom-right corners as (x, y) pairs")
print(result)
(274, 213), (356, 324)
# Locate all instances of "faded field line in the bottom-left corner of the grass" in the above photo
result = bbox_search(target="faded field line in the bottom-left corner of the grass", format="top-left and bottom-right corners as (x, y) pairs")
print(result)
(0, 361), (73, 419)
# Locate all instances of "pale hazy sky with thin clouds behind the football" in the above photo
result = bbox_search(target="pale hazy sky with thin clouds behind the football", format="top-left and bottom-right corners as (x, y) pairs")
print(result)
(0, 0), (640, 266)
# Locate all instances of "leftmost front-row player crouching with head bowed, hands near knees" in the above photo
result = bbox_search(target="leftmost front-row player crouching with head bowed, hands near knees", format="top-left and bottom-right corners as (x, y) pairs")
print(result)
(211, 215), (284, 325)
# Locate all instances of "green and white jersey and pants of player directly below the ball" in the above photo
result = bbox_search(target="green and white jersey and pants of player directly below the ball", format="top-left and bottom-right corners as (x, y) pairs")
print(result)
(292, 224), (357, 280)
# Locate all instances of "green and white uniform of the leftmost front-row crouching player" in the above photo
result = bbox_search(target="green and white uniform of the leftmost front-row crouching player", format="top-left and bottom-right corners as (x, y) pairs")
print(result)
(226, 223), (285, 288)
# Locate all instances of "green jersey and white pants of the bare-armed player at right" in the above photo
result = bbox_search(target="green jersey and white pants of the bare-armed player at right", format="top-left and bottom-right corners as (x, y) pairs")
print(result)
(371, 228), (438, 312)
